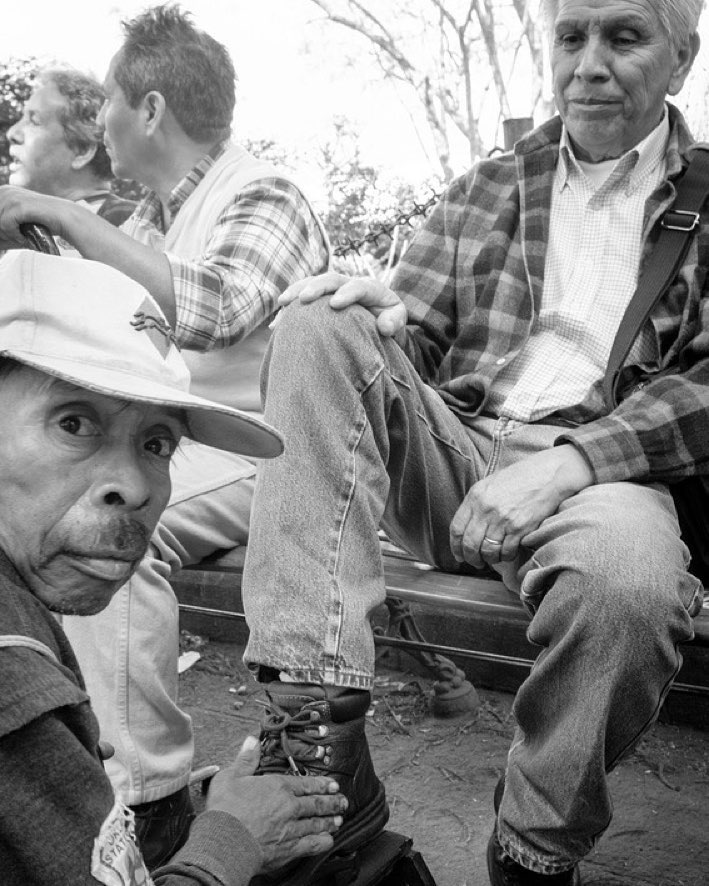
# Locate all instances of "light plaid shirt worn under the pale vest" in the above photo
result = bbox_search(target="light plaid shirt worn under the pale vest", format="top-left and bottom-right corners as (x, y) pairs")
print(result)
(121, 142), (328, 351)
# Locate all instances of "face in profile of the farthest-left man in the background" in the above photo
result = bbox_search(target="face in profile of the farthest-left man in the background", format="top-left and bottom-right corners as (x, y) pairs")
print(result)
(7, 83), (75, 197)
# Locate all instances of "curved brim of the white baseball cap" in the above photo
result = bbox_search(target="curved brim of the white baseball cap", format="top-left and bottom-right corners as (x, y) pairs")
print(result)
(0, 349), (283, 458)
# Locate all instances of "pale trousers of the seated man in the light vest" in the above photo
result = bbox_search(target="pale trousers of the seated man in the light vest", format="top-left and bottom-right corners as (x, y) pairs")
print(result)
(62, 440), (255, 806)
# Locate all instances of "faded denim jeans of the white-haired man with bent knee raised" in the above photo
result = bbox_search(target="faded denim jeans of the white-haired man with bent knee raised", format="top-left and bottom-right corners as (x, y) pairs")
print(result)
(243, 299), (702, 873)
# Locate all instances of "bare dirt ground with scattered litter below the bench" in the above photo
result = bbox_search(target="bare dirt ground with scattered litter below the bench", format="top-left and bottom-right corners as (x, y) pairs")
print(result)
(180, 635), (709, 886)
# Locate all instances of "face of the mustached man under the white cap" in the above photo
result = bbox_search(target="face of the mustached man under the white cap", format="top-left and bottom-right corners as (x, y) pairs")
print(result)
(0, 367), (183, 615)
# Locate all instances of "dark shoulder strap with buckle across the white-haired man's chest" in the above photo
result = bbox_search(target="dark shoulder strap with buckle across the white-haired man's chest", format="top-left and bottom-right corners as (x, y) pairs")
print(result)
(603, 144), (709, 409)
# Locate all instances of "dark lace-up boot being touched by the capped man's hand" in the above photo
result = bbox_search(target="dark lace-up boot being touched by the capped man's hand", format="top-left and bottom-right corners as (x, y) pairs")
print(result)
(256, 681), (389, 884)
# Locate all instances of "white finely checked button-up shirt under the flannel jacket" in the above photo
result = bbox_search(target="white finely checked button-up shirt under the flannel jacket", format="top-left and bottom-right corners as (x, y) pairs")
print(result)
(488, 116), (670, 421)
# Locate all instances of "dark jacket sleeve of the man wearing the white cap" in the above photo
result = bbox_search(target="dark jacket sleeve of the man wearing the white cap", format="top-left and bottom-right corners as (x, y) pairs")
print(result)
(0, 706), (261, 886)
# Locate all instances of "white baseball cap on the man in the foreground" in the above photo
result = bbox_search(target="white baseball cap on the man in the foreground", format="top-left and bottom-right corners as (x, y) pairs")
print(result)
(0, 249), (283, 458)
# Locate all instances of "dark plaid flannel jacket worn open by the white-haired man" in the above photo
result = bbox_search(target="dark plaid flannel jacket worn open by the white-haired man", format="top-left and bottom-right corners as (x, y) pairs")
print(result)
(392, 106), (709, 490)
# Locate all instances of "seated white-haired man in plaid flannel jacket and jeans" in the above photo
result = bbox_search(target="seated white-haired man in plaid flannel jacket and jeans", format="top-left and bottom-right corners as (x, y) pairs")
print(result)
(236, 0), (709, 886)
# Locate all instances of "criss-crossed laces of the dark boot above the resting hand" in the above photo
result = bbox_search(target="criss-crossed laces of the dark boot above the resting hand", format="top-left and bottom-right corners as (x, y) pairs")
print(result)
(256, 699), (327, 775)
